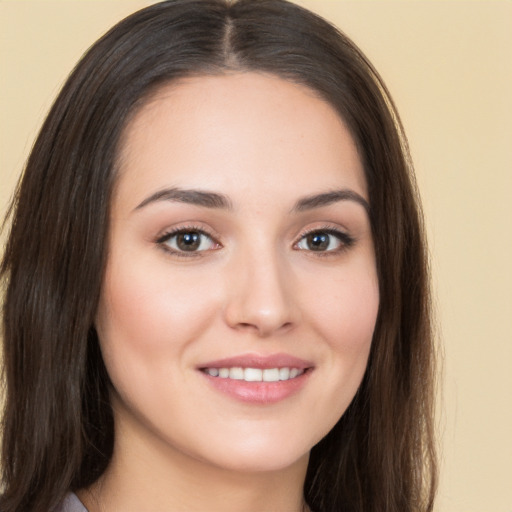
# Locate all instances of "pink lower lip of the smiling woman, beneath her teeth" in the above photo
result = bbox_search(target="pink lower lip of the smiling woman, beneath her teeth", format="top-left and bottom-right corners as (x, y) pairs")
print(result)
(201, 369), (311, 404)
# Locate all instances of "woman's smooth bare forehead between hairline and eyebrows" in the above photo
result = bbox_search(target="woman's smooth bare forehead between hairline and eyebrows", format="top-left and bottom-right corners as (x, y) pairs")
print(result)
(115, 72), (367, 209)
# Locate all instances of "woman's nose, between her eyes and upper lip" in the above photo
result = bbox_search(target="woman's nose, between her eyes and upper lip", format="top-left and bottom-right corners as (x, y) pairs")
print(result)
(224, 247), (300, 338)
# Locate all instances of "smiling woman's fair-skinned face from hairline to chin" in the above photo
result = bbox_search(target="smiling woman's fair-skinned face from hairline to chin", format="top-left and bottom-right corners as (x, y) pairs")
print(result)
(96, 73), (379, 471)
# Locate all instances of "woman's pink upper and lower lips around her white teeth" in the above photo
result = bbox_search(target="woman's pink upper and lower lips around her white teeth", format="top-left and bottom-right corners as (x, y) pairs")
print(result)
(198, 354), (313, 405)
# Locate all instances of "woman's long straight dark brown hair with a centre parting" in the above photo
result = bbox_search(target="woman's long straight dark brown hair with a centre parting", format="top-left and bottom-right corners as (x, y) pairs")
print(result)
(0, 0), (437, 512)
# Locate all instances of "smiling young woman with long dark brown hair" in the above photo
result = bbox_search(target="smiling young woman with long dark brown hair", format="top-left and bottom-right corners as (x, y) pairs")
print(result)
(0, 0), (436, 512)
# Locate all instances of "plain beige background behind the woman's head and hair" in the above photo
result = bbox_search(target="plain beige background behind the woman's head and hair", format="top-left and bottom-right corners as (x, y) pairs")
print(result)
(0, 0), (512, 512)
